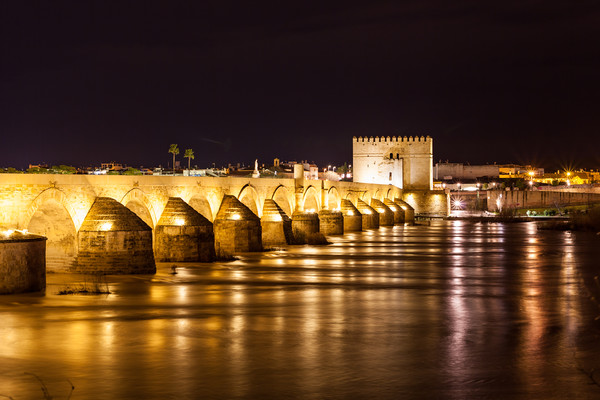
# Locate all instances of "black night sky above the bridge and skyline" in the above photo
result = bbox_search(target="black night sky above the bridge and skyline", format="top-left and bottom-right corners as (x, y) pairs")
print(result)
(0, 0), (600, 169)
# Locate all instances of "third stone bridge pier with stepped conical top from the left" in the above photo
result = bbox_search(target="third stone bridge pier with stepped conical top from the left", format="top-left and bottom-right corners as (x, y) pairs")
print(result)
(213, 195), (262, 258)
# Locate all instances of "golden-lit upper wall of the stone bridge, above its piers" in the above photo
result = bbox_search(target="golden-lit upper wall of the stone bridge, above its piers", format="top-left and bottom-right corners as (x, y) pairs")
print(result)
(0, 174), (448, 270)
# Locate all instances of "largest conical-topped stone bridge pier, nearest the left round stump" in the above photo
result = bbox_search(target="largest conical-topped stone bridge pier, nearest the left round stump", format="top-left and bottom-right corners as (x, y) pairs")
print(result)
(75, 197), (156, 274)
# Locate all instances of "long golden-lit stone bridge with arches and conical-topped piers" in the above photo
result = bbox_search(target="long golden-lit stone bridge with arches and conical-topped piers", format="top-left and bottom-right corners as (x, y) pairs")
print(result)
(0, 174), (448, 273)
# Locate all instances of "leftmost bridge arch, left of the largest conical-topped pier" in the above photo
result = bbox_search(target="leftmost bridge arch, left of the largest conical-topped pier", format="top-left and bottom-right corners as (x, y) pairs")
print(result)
(24, 188), (78, 272)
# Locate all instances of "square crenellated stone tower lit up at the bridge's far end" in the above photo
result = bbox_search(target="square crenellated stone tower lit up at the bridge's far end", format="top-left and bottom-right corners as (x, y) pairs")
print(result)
(352, 136), (433, 190)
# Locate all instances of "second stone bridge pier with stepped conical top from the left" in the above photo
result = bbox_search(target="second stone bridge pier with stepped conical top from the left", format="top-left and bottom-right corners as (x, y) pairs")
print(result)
(154, 197), (215, 262)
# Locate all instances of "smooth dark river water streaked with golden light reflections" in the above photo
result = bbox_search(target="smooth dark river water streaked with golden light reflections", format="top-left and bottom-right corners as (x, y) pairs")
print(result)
(0, 221), (600, 400)
